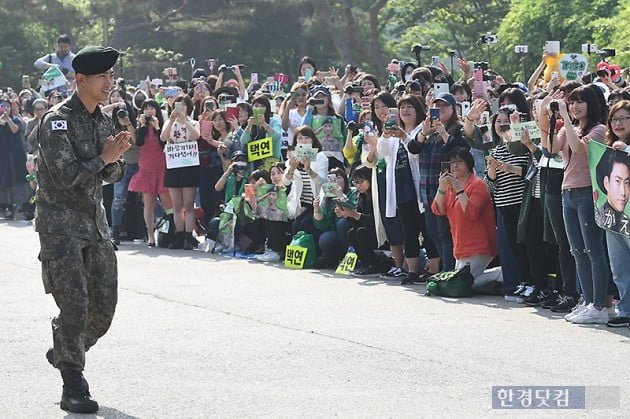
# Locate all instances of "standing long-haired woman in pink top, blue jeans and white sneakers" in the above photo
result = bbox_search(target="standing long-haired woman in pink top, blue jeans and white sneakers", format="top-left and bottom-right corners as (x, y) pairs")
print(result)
(549, 84), (610, 324)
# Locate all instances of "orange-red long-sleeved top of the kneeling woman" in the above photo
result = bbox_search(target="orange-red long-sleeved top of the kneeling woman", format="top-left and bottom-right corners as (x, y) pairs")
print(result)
(431, 174), (497, 259)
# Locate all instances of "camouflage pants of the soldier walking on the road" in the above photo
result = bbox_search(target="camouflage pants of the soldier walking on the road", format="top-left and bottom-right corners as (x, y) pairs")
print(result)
(39, 233), (118, 370)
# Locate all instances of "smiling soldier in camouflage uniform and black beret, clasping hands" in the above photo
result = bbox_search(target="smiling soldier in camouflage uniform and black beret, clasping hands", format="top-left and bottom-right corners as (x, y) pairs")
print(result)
(35, 47), (130, 413)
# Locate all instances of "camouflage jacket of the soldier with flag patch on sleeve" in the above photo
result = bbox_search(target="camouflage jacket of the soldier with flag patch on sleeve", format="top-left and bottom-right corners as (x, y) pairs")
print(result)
(35, 93), (126, 240)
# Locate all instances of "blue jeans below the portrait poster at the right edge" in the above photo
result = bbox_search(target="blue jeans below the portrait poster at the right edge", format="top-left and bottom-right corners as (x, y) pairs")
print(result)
(606, 231), (630, 317)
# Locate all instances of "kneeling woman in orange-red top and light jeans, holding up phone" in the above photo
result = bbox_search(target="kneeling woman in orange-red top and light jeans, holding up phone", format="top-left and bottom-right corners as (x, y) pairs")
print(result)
(431, 147), (503, 286)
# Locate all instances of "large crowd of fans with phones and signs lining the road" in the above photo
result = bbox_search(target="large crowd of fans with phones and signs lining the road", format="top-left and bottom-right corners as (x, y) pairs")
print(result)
(0, 37), (630, 326)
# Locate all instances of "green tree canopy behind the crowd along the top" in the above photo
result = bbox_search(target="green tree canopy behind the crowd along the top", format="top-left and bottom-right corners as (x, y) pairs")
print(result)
(0, 0), (630, 86)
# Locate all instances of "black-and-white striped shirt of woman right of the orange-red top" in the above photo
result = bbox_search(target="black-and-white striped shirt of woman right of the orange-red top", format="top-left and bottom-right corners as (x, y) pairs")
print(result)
(486, 144), (529, 207)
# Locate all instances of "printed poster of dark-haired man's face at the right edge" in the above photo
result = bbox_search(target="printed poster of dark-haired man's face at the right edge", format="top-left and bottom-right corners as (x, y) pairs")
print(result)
(588, 141), (630, 237)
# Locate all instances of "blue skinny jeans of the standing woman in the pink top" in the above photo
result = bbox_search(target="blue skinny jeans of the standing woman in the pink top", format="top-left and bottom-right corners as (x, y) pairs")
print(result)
(562, 187), (610, 307)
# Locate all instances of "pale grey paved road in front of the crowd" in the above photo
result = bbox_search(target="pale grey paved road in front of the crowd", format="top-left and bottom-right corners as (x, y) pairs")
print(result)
(0, 221), (630, 418)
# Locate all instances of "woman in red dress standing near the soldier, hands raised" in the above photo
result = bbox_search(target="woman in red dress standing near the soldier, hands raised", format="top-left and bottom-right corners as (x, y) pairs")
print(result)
(129, 99), (173, 247)
